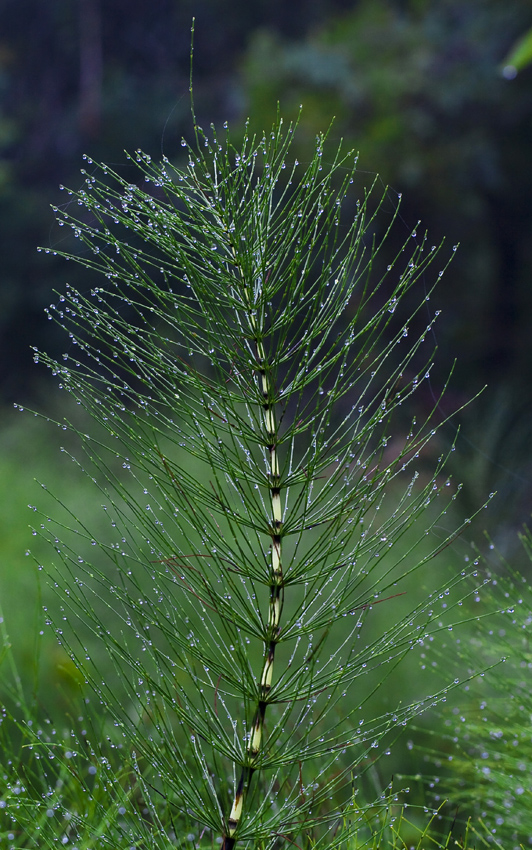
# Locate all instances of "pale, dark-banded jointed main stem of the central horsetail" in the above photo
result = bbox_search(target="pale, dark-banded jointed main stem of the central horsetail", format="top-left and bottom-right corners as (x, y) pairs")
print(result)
(222, 315), (284, 850)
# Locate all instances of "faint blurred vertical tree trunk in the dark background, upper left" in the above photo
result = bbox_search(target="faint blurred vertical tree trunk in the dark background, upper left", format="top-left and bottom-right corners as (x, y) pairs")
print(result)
(79, 0), (103, 136)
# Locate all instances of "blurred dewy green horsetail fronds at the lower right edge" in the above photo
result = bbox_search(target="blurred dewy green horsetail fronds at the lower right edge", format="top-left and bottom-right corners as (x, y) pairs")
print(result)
(424, 529), (532, 850)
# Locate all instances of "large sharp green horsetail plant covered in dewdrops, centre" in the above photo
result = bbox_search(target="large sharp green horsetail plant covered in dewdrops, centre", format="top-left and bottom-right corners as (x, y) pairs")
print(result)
(27, 114), (488, 850)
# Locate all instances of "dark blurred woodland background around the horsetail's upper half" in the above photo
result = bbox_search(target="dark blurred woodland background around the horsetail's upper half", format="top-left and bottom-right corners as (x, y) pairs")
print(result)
(0, 0), (532, 536)
